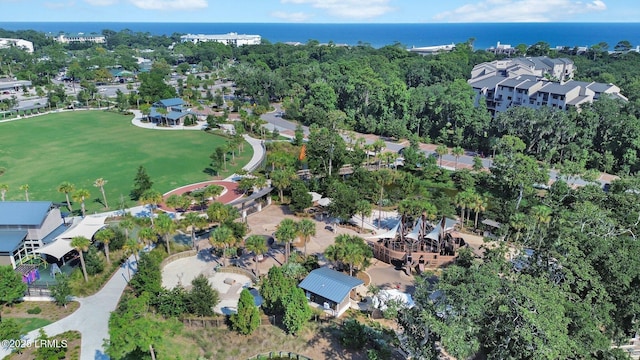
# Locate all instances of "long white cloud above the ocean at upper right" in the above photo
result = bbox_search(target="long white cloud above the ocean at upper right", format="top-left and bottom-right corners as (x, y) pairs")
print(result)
(434, 0), (607, 22)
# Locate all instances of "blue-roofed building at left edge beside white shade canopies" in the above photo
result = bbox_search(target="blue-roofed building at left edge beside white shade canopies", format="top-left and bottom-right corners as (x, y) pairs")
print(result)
(0, 201), (64, 268)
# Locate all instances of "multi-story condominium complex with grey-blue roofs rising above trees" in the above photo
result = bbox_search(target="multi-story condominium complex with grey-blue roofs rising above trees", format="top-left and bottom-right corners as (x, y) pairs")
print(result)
(468, 57), (627, 115)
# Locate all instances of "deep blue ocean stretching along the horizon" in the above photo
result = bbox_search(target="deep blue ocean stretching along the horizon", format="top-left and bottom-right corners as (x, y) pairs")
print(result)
(0, 22), (640, 50)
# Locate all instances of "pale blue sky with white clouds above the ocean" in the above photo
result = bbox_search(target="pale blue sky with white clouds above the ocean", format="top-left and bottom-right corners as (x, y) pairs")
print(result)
(0, 0), (640, 22)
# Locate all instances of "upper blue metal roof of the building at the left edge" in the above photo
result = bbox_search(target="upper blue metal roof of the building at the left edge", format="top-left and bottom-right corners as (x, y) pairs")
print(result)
(0, 201), (52, 226)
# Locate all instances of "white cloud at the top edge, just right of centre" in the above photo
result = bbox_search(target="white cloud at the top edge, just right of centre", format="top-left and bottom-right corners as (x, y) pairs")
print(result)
(280, 0), (394, 20)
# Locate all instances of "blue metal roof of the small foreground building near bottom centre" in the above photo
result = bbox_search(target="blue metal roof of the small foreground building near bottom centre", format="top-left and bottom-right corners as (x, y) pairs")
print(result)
(298, 267), (364, 303)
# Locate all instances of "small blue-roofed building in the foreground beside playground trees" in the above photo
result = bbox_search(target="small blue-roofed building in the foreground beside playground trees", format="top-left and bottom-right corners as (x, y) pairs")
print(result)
(298, 267), (364, 317)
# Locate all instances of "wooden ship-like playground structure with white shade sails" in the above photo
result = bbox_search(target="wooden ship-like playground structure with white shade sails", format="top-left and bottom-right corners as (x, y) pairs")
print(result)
(367, 216), (466, 274)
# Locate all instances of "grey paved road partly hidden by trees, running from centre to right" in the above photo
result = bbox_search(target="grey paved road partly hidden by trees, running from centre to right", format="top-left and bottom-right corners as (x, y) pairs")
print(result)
(261, 104), (617, 186)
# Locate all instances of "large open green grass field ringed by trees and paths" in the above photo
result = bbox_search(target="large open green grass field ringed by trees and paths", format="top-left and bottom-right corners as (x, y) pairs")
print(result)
(0, 111), (253, 213)
